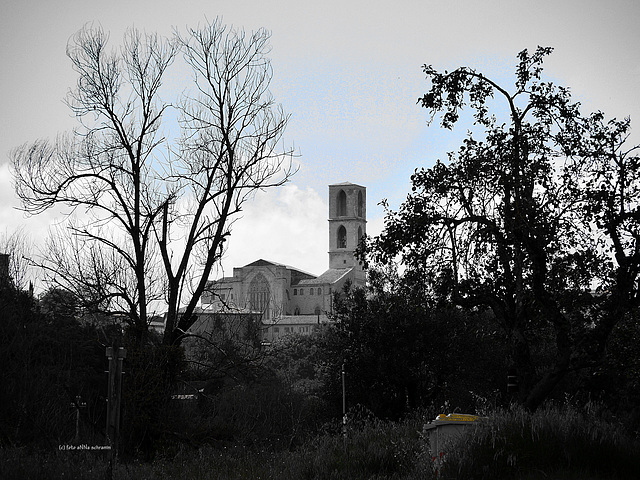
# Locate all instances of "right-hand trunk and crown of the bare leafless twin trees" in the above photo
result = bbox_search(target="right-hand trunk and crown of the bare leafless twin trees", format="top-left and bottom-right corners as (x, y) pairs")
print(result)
(160, 22), (293, 343)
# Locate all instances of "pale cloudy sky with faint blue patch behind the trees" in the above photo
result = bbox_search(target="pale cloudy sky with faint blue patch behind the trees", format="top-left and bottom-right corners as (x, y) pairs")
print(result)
(0, 0), (640, 284)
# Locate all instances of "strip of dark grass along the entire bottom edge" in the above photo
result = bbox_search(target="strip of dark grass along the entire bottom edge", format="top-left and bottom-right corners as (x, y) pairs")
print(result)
(0, 407), (640, 480)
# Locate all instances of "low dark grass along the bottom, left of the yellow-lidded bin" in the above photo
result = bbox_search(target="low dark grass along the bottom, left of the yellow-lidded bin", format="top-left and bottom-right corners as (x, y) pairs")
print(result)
(0, 416), (429, 480)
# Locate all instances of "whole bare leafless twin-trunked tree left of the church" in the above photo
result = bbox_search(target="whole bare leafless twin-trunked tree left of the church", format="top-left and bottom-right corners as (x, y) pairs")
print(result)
(12, 21), (294, 343)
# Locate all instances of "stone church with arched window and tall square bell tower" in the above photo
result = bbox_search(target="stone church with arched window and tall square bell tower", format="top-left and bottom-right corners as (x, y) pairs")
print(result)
(199, 182), (367, 344)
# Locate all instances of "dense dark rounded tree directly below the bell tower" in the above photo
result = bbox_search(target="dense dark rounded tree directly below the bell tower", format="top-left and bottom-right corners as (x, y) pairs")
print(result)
(326, 276), (507, 418)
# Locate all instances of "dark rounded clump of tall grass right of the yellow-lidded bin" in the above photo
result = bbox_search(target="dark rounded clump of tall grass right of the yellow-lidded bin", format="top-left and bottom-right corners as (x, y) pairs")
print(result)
(441, 406), (640, 480)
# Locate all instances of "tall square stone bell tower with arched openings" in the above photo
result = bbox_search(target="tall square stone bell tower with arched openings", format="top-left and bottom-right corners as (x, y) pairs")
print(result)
(329, 182), (367, 281)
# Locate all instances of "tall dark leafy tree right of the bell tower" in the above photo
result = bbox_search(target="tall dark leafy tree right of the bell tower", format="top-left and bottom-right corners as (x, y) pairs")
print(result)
(368, 47), (640, 408)
